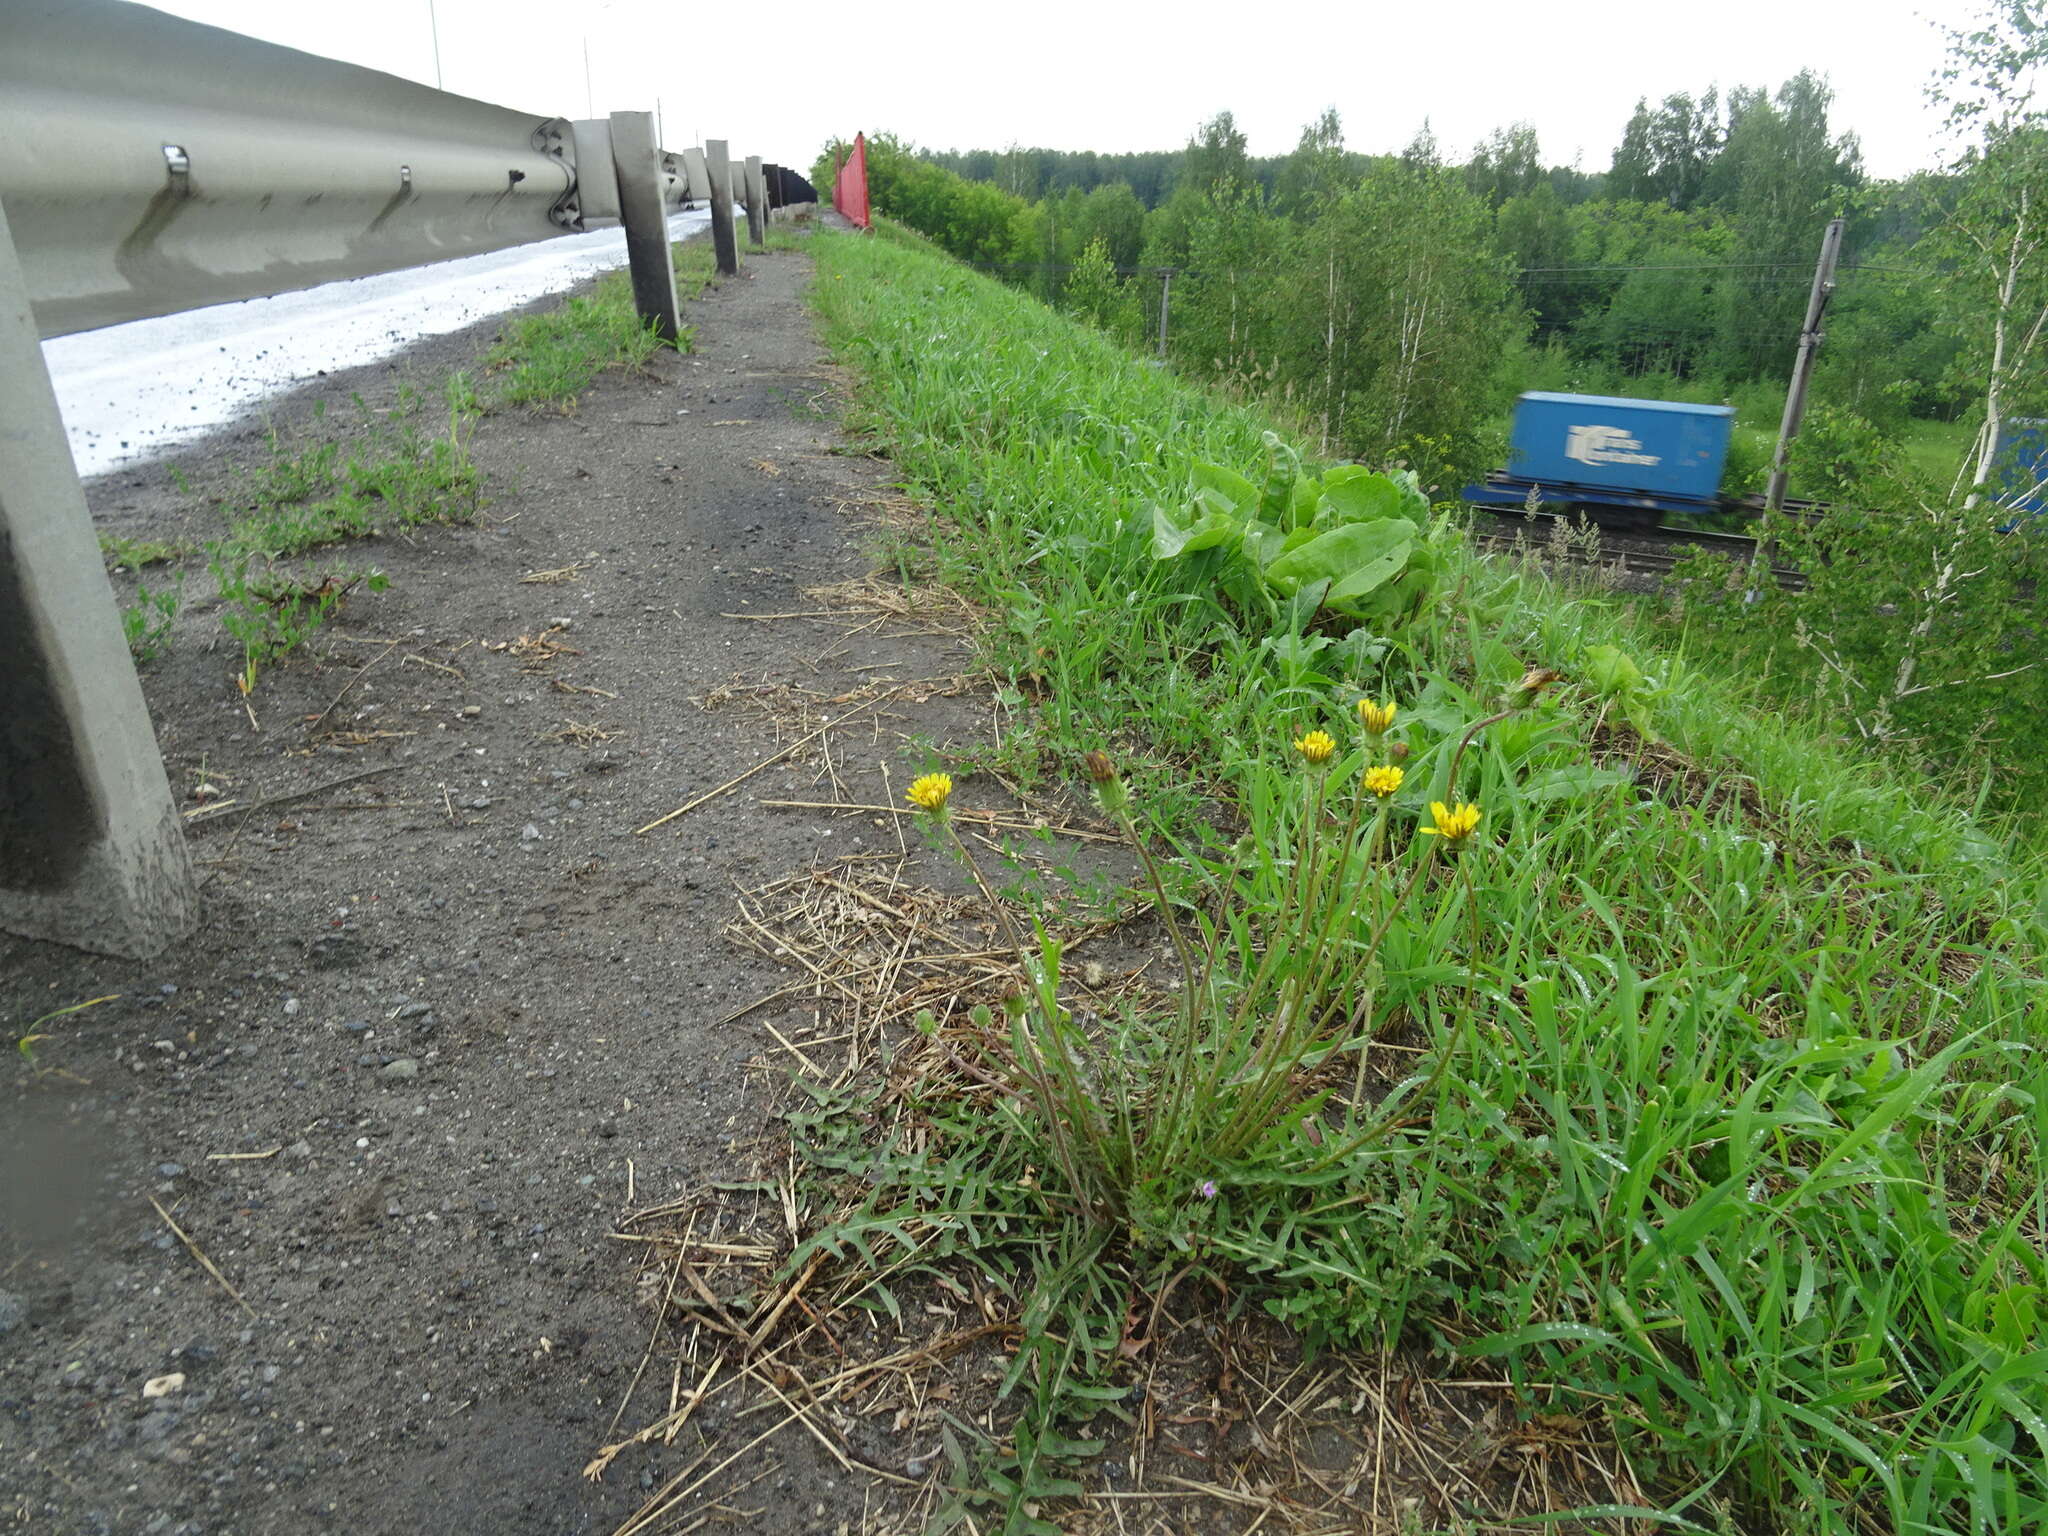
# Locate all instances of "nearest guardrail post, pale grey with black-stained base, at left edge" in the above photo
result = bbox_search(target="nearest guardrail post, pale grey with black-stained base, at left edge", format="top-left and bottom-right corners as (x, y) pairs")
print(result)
(0, 198), (199, 958)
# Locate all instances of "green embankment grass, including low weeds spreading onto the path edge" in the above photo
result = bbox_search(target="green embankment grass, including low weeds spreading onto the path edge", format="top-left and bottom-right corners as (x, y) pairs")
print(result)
(799, 222), (2048, 1532)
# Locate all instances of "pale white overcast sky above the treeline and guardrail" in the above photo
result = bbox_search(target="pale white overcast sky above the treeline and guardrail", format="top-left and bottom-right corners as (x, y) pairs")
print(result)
(158, 0), (1974, 176)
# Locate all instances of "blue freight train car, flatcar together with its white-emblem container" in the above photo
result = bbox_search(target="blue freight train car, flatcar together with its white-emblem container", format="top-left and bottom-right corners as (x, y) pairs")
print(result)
(1464, 393), (1761, 528)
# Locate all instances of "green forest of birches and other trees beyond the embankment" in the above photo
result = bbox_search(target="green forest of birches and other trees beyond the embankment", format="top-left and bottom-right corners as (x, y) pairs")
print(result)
(817, 0), (2048, 843)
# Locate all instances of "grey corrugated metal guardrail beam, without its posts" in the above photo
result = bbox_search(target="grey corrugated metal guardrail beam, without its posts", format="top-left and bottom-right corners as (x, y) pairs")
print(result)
(0, 0), (729, 336)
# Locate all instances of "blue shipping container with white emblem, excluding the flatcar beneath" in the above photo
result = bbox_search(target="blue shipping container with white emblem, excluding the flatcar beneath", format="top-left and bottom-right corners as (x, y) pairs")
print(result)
(1507, 393), (1735, 504)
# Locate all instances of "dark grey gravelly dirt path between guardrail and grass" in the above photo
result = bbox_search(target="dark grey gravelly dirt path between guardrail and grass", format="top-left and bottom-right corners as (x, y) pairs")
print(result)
(0, 237), (987, 1536)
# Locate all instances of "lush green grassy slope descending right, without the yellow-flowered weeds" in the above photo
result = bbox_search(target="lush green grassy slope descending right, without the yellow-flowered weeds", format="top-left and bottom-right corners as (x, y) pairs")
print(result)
(817, 228), (2048, 1530)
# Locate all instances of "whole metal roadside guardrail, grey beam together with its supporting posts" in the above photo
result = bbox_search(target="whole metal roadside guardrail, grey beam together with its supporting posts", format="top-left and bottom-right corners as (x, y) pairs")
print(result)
(0, 0), (786, 956)
